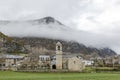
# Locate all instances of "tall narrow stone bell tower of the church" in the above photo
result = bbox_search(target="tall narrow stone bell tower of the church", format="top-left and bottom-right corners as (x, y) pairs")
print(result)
(56, 42), (62, 70)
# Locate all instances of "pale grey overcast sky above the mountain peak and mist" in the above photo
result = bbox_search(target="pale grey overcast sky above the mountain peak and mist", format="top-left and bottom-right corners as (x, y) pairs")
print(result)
(0, 0), (120, 53)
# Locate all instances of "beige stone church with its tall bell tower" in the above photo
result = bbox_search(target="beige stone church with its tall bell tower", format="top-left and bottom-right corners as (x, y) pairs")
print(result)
(56, 42), (85, 71)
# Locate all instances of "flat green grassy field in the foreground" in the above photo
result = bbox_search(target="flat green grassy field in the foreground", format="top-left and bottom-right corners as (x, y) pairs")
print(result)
(0, 71), (120, 80)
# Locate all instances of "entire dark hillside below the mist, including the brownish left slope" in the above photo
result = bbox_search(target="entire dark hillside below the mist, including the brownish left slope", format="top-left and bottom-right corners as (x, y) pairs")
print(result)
(0, 32), (116, 57)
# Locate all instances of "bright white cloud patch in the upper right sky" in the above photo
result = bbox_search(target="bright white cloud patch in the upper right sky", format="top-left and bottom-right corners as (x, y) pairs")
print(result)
(76, 0), (120, 34)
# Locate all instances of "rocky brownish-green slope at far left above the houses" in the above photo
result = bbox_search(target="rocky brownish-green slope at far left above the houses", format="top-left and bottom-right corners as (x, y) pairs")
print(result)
(0, 32), (27, 54)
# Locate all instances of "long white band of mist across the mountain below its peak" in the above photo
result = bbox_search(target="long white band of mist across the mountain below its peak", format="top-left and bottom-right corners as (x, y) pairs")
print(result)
(0, 22), (118, 51)
